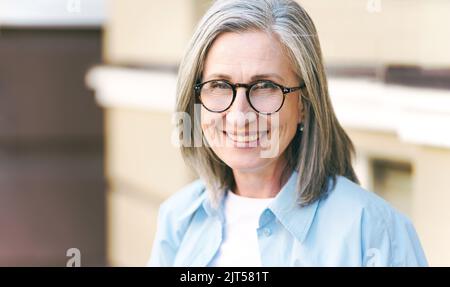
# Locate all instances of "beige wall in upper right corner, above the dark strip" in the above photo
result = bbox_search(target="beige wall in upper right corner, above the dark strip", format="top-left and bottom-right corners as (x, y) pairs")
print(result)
(299, 0), (450, 67)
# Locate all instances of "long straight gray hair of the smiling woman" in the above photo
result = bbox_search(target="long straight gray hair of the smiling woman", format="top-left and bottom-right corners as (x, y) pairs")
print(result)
(176, 0), (358, 205)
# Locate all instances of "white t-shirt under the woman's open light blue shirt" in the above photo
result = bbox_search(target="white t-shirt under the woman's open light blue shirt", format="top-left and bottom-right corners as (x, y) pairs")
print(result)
(210, 191), (273, 267)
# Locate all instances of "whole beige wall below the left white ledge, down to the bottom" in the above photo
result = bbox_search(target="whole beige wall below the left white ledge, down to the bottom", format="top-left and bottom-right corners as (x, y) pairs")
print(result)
(105, 108), (194, 266)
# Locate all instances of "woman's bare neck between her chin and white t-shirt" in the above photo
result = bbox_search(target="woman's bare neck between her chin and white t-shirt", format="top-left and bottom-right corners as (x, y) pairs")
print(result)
(233, 161), (290, 198)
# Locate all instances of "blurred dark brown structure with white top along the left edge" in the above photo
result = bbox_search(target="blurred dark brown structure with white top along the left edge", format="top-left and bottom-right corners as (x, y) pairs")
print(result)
(0, 0), (106, 266)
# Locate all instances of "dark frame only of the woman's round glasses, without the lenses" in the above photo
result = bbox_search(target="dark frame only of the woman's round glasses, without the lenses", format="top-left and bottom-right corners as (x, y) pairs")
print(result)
(194, 79), (306, 115)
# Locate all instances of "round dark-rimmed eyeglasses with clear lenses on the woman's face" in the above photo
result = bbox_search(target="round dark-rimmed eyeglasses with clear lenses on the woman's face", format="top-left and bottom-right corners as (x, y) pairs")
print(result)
(194, 80), (305, 115)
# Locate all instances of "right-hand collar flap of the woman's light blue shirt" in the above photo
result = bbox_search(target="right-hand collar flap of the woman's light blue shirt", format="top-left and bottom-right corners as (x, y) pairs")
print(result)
(269, 171), (319, 245)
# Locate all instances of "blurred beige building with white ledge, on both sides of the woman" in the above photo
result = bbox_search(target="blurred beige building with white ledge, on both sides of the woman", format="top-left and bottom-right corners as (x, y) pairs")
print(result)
(86, 0), (450, 266)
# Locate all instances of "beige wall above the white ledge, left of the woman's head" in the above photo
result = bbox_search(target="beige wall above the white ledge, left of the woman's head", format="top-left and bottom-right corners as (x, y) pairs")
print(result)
(104, 0), (209, 65)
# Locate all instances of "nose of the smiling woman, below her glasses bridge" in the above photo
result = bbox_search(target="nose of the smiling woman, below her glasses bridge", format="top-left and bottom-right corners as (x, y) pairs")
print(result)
(226, 87), (256, 127)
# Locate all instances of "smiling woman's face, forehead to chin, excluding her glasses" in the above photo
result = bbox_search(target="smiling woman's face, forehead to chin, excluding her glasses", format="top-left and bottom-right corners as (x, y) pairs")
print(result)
(201, 31), (303, 172)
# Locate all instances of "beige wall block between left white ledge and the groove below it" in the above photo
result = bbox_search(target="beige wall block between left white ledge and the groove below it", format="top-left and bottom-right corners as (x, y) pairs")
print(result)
(106, 108), (191, 198)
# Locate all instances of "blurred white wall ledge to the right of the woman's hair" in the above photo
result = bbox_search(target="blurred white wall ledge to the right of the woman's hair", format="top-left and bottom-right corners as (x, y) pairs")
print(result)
(329, 79), (450, 148)
